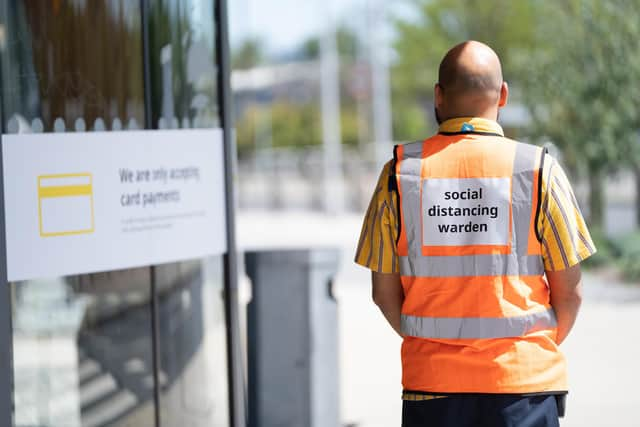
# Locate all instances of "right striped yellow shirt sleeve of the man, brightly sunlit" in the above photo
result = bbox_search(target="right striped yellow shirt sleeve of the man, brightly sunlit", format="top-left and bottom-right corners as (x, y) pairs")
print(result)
(537, 155), (596, 271)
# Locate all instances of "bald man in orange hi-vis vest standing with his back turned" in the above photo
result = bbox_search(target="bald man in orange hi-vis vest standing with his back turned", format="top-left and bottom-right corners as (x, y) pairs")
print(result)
(356, 41), (595, 427)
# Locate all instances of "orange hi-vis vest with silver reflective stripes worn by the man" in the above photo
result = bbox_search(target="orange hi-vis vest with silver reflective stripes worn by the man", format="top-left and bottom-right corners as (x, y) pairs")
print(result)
(394, 120), (567, 394)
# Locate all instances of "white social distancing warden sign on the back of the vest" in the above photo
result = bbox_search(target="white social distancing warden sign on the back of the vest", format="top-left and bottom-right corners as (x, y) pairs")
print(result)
(422, 178), (511, 246)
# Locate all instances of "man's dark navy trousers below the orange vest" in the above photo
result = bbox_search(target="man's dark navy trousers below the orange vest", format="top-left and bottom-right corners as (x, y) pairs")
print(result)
(402, 396), (560, 427)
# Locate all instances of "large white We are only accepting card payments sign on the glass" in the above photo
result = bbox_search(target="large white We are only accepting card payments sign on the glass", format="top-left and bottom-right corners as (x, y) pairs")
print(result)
(2, 129), (227, 281)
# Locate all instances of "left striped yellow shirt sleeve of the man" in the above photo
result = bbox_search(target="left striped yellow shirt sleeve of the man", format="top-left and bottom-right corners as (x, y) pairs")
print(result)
(355, 162), (399, 273)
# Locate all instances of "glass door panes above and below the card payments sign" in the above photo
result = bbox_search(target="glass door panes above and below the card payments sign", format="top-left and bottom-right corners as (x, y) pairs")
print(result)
(0, 0), (229, 427)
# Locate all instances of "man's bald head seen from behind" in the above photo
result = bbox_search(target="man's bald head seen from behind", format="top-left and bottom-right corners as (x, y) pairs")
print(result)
(436, 41), (507, 120)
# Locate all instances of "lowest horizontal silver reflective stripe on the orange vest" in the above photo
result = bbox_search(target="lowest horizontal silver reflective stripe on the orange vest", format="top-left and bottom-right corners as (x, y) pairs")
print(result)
(400, 308), (557, 339)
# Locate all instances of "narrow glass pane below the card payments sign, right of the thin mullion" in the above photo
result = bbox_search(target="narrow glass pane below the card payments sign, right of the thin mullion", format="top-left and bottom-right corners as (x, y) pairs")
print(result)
(155, 257), (229, 427)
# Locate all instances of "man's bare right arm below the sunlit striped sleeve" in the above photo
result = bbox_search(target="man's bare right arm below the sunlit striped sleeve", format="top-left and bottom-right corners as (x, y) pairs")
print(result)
(546, 264), (582, 344)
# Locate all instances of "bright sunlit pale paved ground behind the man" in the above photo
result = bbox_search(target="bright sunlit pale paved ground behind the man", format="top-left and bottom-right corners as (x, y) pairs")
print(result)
(238, 212), (640, 427)
